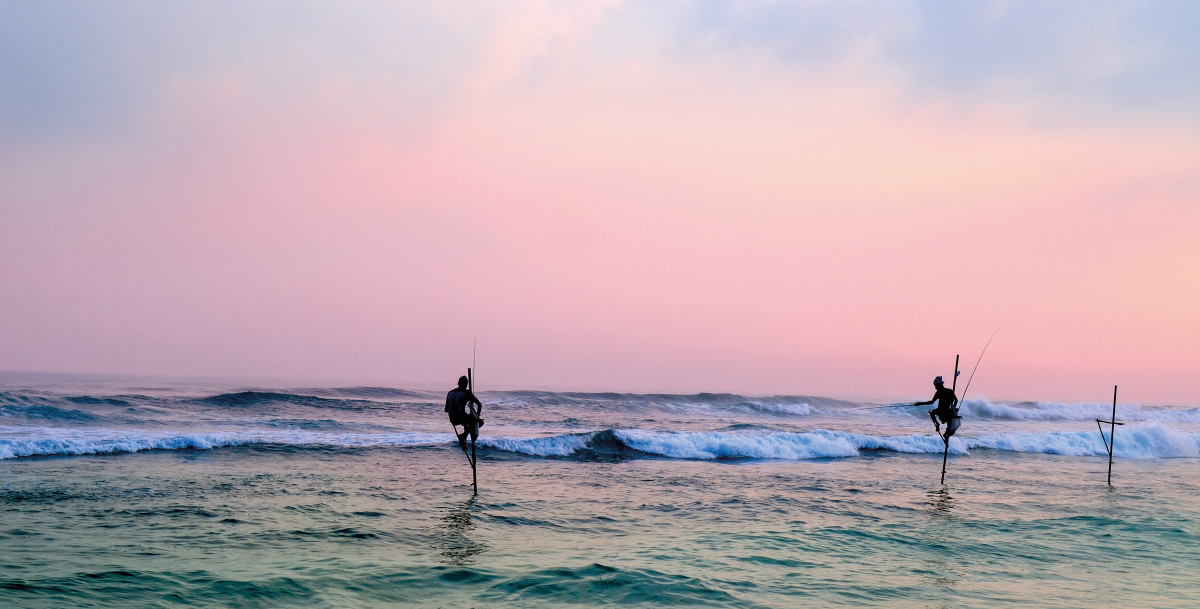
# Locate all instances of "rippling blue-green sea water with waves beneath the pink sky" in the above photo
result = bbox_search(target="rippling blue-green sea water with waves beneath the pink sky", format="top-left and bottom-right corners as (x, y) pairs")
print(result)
(0, 375), (1200, 608)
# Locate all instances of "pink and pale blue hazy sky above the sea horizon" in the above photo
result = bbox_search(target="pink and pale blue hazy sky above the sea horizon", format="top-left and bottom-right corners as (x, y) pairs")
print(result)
(0, 0), (1200, 404)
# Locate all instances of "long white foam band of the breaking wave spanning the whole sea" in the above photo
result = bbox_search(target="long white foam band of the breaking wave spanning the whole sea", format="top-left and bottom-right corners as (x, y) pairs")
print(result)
(0, 422), (1200, 459)
